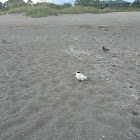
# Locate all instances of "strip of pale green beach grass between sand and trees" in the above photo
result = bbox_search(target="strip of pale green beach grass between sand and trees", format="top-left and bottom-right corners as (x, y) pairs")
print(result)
(0, 6), (140, 18)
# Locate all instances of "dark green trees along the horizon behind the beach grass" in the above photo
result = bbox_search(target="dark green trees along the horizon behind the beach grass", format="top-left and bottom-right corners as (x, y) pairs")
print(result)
(0, 0), (140, 10)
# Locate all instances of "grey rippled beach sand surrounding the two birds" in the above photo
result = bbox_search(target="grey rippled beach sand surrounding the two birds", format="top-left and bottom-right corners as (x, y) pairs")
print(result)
(0, 12), (140, 140)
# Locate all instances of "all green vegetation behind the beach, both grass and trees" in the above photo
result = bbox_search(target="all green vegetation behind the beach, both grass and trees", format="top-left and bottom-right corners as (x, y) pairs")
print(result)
(0, 0), (140, 17)
